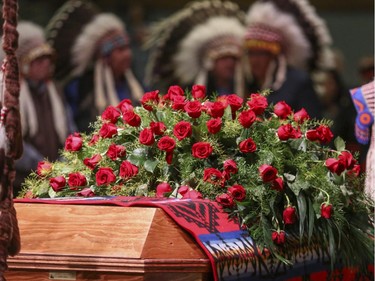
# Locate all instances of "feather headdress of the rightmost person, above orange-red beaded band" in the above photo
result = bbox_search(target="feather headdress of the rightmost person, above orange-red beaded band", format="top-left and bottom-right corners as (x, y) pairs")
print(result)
(246, 0), (334, 71)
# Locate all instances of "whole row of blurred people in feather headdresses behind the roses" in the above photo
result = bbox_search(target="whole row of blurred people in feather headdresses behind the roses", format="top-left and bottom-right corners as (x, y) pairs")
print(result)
(0, 0), (374, 197)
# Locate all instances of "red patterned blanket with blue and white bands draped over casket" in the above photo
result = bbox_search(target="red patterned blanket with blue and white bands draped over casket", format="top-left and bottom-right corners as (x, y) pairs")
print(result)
(15, 197), (374, 281)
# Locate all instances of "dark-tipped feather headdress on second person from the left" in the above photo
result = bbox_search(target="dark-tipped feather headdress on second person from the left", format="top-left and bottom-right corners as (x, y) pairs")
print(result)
(46, 0), (128, 82)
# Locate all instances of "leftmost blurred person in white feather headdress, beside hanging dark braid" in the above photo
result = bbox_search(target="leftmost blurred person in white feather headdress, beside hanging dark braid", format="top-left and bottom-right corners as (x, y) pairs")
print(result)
(1, 21), (75, 196)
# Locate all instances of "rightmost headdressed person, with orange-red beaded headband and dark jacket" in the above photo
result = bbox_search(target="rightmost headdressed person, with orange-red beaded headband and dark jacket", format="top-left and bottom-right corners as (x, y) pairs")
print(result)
(244, 0), (333, 118)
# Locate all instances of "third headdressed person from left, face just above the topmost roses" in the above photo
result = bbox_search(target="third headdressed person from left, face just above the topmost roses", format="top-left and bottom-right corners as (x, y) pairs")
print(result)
(145, 1), (245, 96)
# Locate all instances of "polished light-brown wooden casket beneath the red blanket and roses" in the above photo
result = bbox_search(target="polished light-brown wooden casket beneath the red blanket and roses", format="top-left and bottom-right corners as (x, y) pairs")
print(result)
(5, 203), (212, 281)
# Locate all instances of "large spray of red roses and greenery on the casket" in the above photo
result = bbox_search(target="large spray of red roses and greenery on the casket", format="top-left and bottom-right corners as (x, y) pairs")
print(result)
(22, 85), (373, 270)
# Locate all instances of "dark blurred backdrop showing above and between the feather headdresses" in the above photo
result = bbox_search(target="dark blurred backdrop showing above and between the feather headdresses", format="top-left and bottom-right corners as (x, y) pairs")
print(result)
(14, 0), (374, 86)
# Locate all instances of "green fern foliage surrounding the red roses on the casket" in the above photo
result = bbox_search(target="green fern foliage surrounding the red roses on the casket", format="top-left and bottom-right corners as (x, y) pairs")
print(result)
(19, 87), (373, 266)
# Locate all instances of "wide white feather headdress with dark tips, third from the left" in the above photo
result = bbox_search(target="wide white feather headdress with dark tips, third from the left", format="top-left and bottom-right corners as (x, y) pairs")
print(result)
(146, 0), (245, 91)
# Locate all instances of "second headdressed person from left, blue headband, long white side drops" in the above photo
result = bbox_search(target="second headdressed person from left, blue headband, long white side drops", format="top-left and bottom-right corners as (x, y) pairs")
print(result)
(46, 0), (144, 132)
